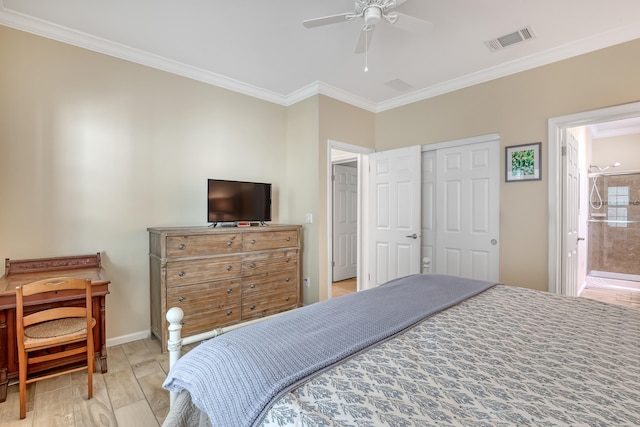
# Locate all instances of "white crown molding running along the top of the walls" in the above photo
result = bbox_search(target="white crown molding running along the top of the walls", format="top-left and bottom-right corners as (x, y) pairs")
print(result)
(0, 4), (640, 113)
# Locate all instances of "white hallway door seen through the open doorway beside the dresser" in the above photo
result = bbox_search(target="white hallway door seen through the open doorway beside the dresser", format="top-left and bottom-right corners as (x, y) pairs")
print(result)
(333, 165), (358, 282)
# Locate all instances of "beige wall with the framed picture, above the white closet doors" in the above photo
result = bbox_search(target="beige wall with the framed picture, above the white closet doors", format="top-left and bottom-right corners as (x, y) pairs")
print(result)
(376, 40), (640, 290)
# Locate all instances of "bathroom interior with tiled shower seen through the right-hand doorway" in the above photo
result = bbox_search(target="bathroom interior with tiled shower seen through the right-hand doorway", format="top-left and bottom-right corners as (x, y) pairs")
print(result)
(568, 118), (640, 295)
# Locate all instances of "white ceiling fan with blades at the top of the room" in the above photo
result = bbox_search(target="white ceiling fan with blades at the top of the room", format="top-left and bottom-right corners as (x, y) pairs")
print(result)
(302, 0), (430, 53)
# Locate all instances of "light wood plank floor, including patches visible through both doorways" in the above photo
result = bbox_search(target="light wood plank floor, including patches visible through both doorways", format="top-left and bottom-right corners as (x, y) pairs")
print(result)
(0, 280), (640, 427)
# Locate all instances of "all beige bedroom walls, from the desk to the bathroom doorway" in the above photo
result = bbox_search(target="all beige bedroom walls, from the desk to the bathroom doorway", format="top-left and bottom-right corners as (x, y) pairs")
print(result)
(0, 26), (640, 338)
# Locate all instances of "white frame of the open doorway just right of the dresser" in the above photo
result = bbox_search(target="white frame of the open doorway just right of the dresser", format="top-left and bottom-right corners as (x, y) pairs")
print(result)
(320, 139), (375, 299)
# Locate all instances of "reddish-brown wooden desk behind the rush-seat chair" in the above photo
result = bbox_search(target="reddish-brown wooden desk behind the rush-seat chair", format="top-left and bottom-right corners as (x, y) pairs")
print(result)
(0, 253), (110, 402)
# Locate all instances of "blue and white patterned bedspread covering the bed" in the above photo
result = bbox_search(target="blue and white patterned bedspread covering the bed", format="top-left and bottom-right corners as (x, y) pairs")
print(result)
(262, 285), (640, 427)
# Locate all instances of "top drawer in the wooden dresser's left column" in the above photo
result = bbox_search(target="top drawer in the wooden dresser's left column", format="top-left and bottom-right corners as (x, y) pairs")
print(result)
(167, 233), (242, 258)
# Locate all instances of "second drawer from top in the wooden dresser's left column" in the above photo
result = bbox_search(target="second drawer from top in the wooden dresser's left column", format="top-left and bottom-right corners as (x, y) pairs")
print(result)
(167, 256), (242, 288)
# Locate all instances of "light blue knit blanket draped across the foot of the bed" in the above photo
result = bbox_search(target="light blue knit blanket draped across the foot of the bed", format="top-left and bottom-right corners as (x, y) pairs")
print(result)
(163, 275), (494, 427)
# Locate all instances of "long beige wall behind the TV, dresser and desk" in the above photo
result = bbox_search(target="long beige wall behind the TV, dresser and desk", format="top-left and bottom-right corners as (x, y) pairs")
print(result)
(0, 26), (300, 338)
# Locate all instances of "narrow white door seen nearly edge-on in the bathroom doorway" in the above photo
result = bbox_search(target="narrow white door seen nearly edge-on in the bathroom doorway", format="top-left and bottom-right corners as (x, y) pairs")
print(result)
(560, 129), (580, 297)
